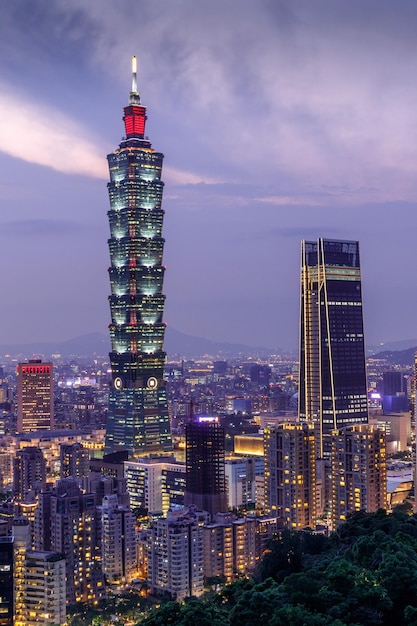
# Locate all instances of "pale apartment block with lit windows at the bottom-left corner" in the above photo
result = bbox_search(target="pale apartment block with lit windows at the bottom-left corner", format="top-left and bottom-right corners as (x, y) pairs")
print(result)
(23, 552), (67, 626)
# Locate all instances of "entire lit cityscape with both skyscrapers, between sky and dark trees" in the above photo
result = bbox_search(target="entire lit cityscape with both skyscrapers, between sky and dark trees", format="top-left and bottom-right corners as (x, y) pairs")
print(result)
(0, 61), (404, 626)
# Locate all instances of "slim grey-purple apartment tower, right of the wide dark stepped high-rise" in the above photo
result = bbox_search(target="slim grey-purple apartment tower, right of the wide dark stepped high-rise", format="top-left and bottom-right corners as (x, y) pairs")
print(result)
(101, 495), (136, 584)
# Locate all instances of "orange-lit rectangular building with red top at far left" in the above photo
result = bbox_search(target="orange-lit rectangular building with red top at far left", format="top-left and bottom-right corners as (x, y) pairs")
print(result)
(17, 359), (54, 433)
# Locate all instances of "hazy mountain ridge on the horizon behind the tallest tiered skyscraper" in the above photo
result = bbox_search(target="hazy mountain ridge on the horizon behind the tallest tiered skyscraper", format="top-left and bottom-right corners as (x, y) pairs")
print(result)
(0, 327), (272, 359)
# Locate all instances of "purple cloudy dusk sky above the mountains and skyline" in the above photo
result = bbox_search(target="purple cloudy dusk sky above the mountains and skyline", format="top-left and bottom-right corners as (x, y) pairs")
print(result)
(0, 0), (417, 348)
